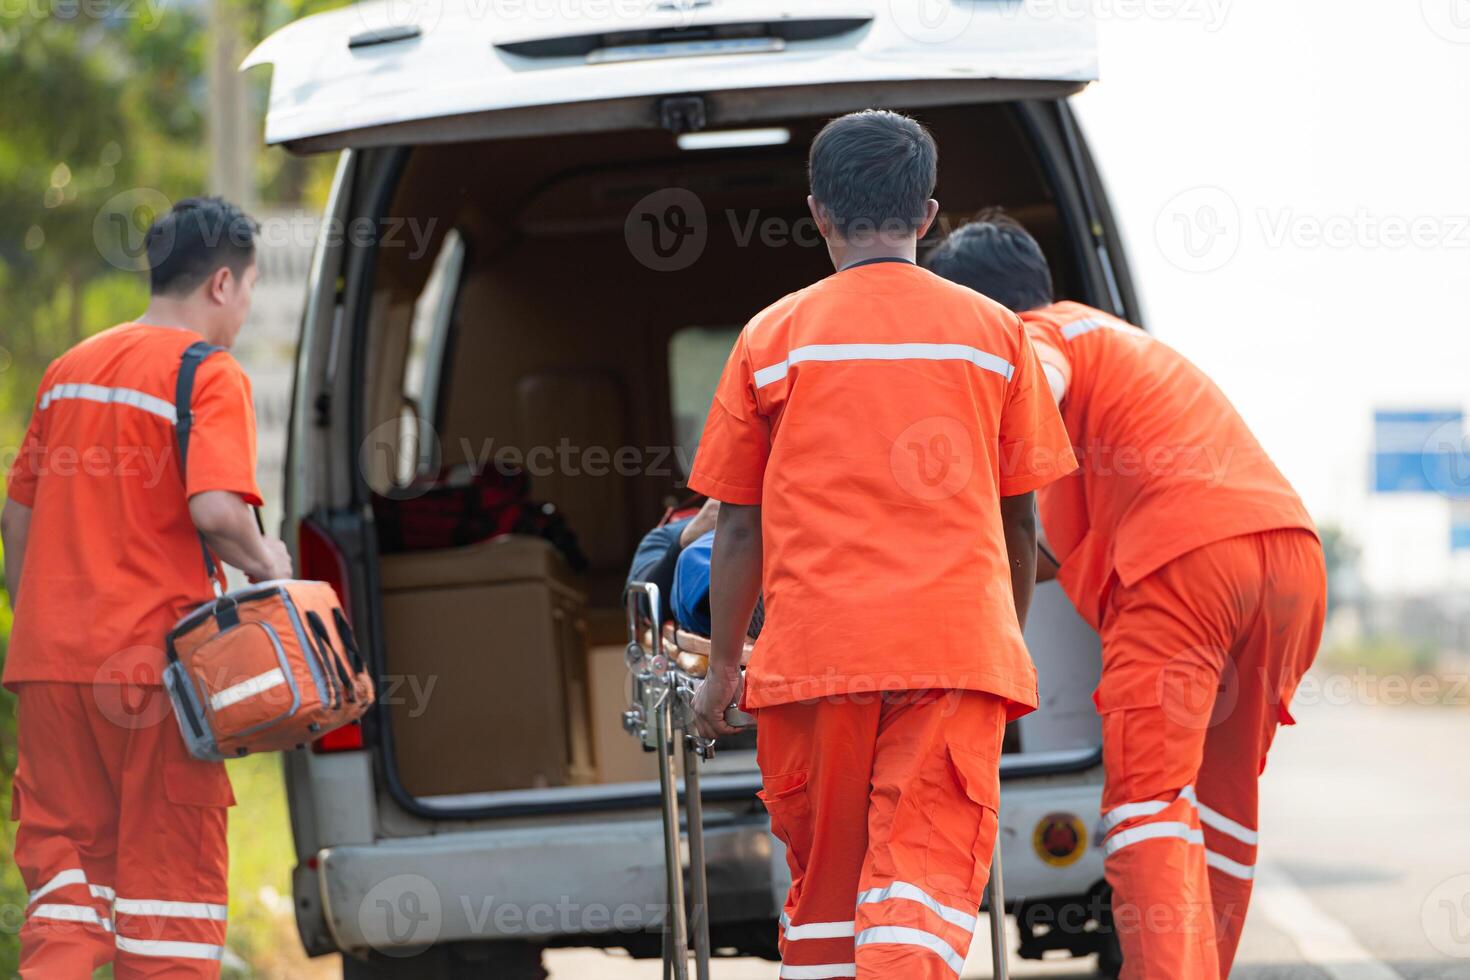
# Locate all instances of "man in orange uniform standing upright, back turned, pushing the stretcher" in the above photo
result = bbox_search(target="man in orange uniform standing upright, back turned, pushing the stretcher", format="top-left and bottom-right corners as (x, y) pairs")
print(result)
(689, 112), (1075, 980)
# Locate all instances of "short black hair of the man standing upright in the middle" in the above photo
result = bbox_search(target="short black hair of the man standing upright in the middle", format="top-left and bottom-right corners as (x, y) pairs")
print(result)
(807, 109), (939, 237)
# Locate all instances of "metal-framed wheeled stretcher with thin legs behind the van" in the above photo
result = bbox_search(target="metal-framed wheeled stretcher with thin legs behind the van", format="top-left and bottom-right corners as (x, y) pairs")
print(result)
(623, 582), (1010, 980)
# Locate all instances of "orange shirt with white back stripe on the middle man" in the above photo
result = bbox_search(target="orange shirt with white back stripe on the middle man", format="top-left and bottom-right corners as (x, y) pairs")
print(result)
(689, 262), (1076, 716)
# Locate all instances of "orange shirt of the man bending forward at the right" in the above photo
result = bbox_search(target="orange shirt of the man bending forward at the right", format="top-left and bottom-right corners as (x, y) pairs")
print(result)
(1022, 303), (1316, 627)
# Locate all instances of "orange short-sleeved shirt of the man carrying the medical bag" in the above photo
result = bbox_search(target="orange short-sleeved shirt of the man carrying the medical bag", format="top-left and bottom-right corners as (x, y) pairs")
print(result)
(4, 323), (260, 685)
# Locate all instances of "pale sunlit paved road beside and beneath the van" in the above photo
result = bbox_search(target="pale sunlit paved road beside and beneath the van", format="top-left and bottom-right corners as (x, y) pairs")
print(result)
(547, 686), (1470, 980)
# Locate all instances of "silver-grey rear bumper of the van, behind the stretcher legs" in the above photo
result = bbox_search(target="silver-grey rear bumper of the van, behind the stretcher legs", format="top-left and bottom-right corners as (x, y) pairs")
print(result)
(316, 768), (1103, 951)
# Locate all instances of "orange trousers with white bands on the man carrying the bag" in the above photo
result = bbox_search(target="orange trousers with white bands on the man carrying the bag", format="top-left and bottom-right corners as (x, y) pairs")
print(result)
(12, 682), (234, 980)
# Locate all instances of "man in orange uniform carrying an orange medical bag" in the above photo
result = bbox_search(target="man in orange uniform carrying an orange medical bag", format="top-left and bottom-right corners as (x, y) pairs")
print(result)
(0, 198), (291, 980)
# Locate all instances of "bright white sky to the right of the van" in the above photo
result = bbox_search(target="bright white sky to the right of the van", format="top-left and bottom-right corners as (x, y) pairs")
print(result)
(1076, 0), (1470, 591)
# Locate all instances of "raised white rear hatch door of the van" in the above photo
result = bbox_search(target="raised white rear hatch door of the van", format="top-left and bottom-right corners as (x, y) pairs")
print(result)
(243, 0), (1097, 151)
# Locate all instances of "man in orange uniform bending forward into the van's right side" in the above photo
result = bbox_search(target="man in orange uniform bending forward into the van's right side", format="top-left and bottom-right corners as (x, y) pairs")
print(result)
(928, 212), (1326, 980)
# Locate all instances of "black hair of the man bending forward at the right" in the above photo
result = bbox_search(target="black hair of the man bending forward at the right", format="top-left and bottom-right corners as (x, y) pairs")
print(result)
(923, 207), (1053, 313)
